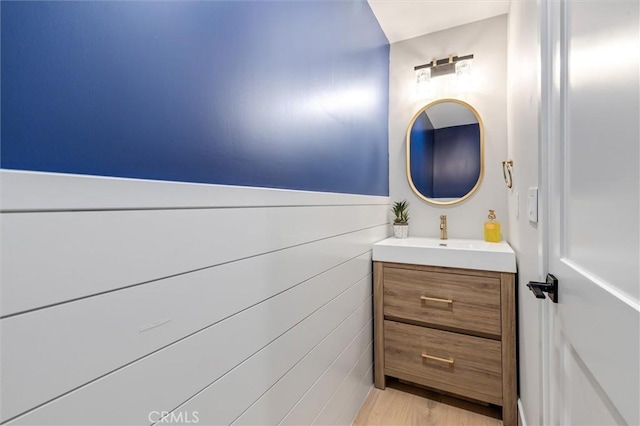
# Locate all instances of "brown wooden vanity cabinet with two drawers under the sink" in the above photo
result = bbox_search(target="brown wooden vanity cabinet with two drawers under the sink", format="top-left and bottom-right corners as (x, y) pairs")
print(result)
(374, 262), (517, 426)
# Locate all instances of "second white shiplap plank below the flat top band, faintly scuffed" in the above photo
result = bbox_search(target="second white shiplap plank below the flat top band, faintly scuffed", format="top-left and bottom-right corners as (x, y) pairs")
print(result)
(0, 225), (387, 419)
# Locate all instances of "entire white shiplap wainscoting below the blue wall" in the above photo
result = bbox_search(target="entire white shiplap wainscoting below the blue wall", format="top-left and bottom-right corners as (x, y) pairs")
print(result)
(0, 170), (389, 425)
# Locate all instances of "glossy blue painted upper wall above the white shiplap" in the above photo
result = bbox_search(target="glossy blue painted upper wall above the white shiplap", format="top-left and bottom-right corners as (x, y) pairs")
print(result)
(0, 0), (389, 195)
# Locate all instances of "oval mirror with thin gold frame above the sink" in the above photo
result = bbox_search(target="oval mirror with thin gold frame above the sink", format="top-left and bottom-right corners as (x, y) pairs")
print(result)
(407, 99), (484, 205)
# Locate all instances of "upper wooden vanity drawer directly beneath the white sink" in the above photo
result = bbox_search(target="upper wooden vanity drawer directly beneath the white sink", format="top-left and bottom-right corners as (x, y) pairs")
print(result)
(383, 266), (501, 336)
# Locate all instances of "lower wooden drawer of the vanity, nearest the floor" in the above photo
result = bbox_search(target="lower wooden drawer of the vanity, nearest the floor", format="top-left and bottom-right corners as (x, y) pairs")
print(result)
(384, 321), (502, 404)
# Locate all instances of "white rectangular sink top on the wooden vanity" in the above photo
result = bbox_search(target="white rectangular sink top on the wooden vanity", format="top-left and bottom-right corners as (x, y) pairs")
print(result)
(373, 237), (516, 272)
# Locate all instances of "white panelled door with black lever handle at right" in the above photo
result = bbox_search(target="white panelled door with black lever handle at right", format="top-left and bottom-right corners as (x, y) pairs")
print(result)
(541, 0), (640, 425)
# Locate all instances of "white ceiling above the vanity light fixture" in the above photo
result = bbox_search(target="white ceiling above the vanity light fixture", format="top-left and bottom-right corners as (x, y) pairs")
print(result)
(367, 0), (511, 43)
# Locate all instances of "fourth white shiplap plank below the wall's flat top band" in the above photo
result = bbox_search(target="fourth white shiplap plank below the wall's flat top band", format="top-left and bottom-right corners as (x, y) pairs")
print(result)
(168, 282), (371, 425)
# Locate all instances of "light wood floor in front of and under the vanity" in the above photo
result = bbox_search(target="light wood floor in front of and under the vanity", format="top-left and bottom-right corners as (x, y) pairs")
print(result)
(353, 381), (502, 426)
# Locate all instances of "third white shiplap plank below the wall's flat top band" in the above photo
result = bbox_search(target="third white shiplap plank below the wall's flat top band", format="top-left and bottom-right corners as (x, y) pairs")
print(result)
(9, 253), (371, 425)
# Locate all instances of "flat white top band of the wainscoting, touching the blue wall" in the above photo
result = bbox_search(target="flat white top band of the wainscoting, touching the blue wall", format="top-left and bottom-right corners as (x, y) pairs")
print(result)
(0, 170), (389, 211)
